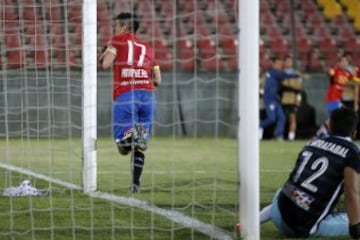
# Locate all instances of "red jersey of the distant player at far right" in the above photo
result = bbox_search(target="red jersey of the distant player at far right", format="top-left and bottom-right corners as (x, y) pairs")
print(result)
(326, 66), (354, 102)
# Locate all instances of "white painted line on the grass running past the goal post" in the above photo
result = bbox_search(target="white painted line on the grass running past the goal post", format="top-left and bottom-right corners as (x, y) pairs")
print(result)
(0, 163), (233, 240)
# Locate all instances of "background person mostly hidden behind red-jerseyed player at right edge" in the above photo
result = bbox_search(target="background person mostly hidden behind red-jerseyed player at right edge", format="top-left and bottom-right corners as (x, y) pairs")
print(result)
(342, 52), (359, 112)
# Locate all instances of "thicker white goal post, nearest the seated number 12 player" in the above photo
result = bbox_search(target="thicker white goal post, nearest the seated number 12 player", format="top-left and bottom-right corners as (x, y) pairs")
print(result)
(238, 0), (260, 240)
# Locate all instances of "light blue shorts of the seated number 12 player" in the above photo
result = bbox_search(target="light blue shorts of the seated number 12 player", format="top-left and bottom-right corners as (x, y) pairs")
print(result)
(271, 190), (350, 237)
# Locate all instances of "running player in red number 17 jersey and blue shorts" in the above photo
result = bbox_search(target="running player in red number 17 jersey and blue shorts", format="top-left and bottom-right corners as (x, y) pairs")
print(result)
(100, 13), (161, 193)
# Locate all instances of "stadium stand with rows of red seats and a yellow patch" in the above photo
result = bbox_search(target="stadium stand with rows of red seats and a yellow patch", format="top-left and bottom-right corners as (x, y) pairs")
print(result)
(0, 0), (360, 71)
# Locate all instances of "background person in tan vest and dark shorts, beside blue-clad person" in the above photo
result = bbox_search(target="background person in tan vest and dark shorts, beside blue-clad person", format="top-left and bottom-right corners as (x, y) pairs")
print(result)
(281, 55), (302, 141)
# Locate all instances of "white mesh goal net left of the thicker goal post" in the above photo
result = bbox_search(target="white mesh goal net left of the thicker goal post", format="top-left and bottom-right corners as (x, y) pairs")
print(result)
(0, 0), (239, 240)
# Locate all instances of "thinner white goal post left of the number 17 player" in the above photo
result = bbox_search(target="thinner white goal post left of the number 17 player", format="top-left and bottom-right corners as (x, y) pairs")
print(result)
(82, 0), (97, 193)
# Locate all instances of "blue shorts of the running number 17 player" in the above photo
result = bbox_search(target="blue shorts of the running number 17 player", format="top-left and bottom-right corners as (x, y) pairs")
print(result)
(113, 90), (155, 142)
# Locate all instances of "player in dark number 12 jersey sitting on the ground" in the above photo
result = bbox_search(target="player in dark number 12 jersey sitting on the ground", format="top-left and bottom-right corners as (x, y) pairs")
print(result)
(260, 108), (360, 239)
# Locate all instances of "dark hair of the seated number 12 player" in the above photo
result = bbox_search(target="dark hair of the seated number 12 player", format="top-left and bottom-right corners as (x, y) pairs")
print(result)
(330, 107), (358, 137)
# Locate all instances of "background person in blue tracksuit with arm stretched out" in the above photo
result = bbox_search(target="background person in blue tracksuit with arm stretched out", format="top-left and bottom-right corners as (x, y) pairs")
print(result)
(259, 57), (298, 140)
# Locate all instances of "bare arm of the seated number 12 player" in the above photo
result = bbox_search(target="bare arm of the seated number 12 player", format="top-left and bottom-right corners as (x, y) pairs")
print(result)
(344, 167), (360, 226)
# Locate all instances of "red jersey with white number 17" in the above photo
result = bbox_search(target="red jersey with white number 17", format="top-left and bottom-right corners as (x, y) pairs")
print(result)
(108, 33), (159, 99)
